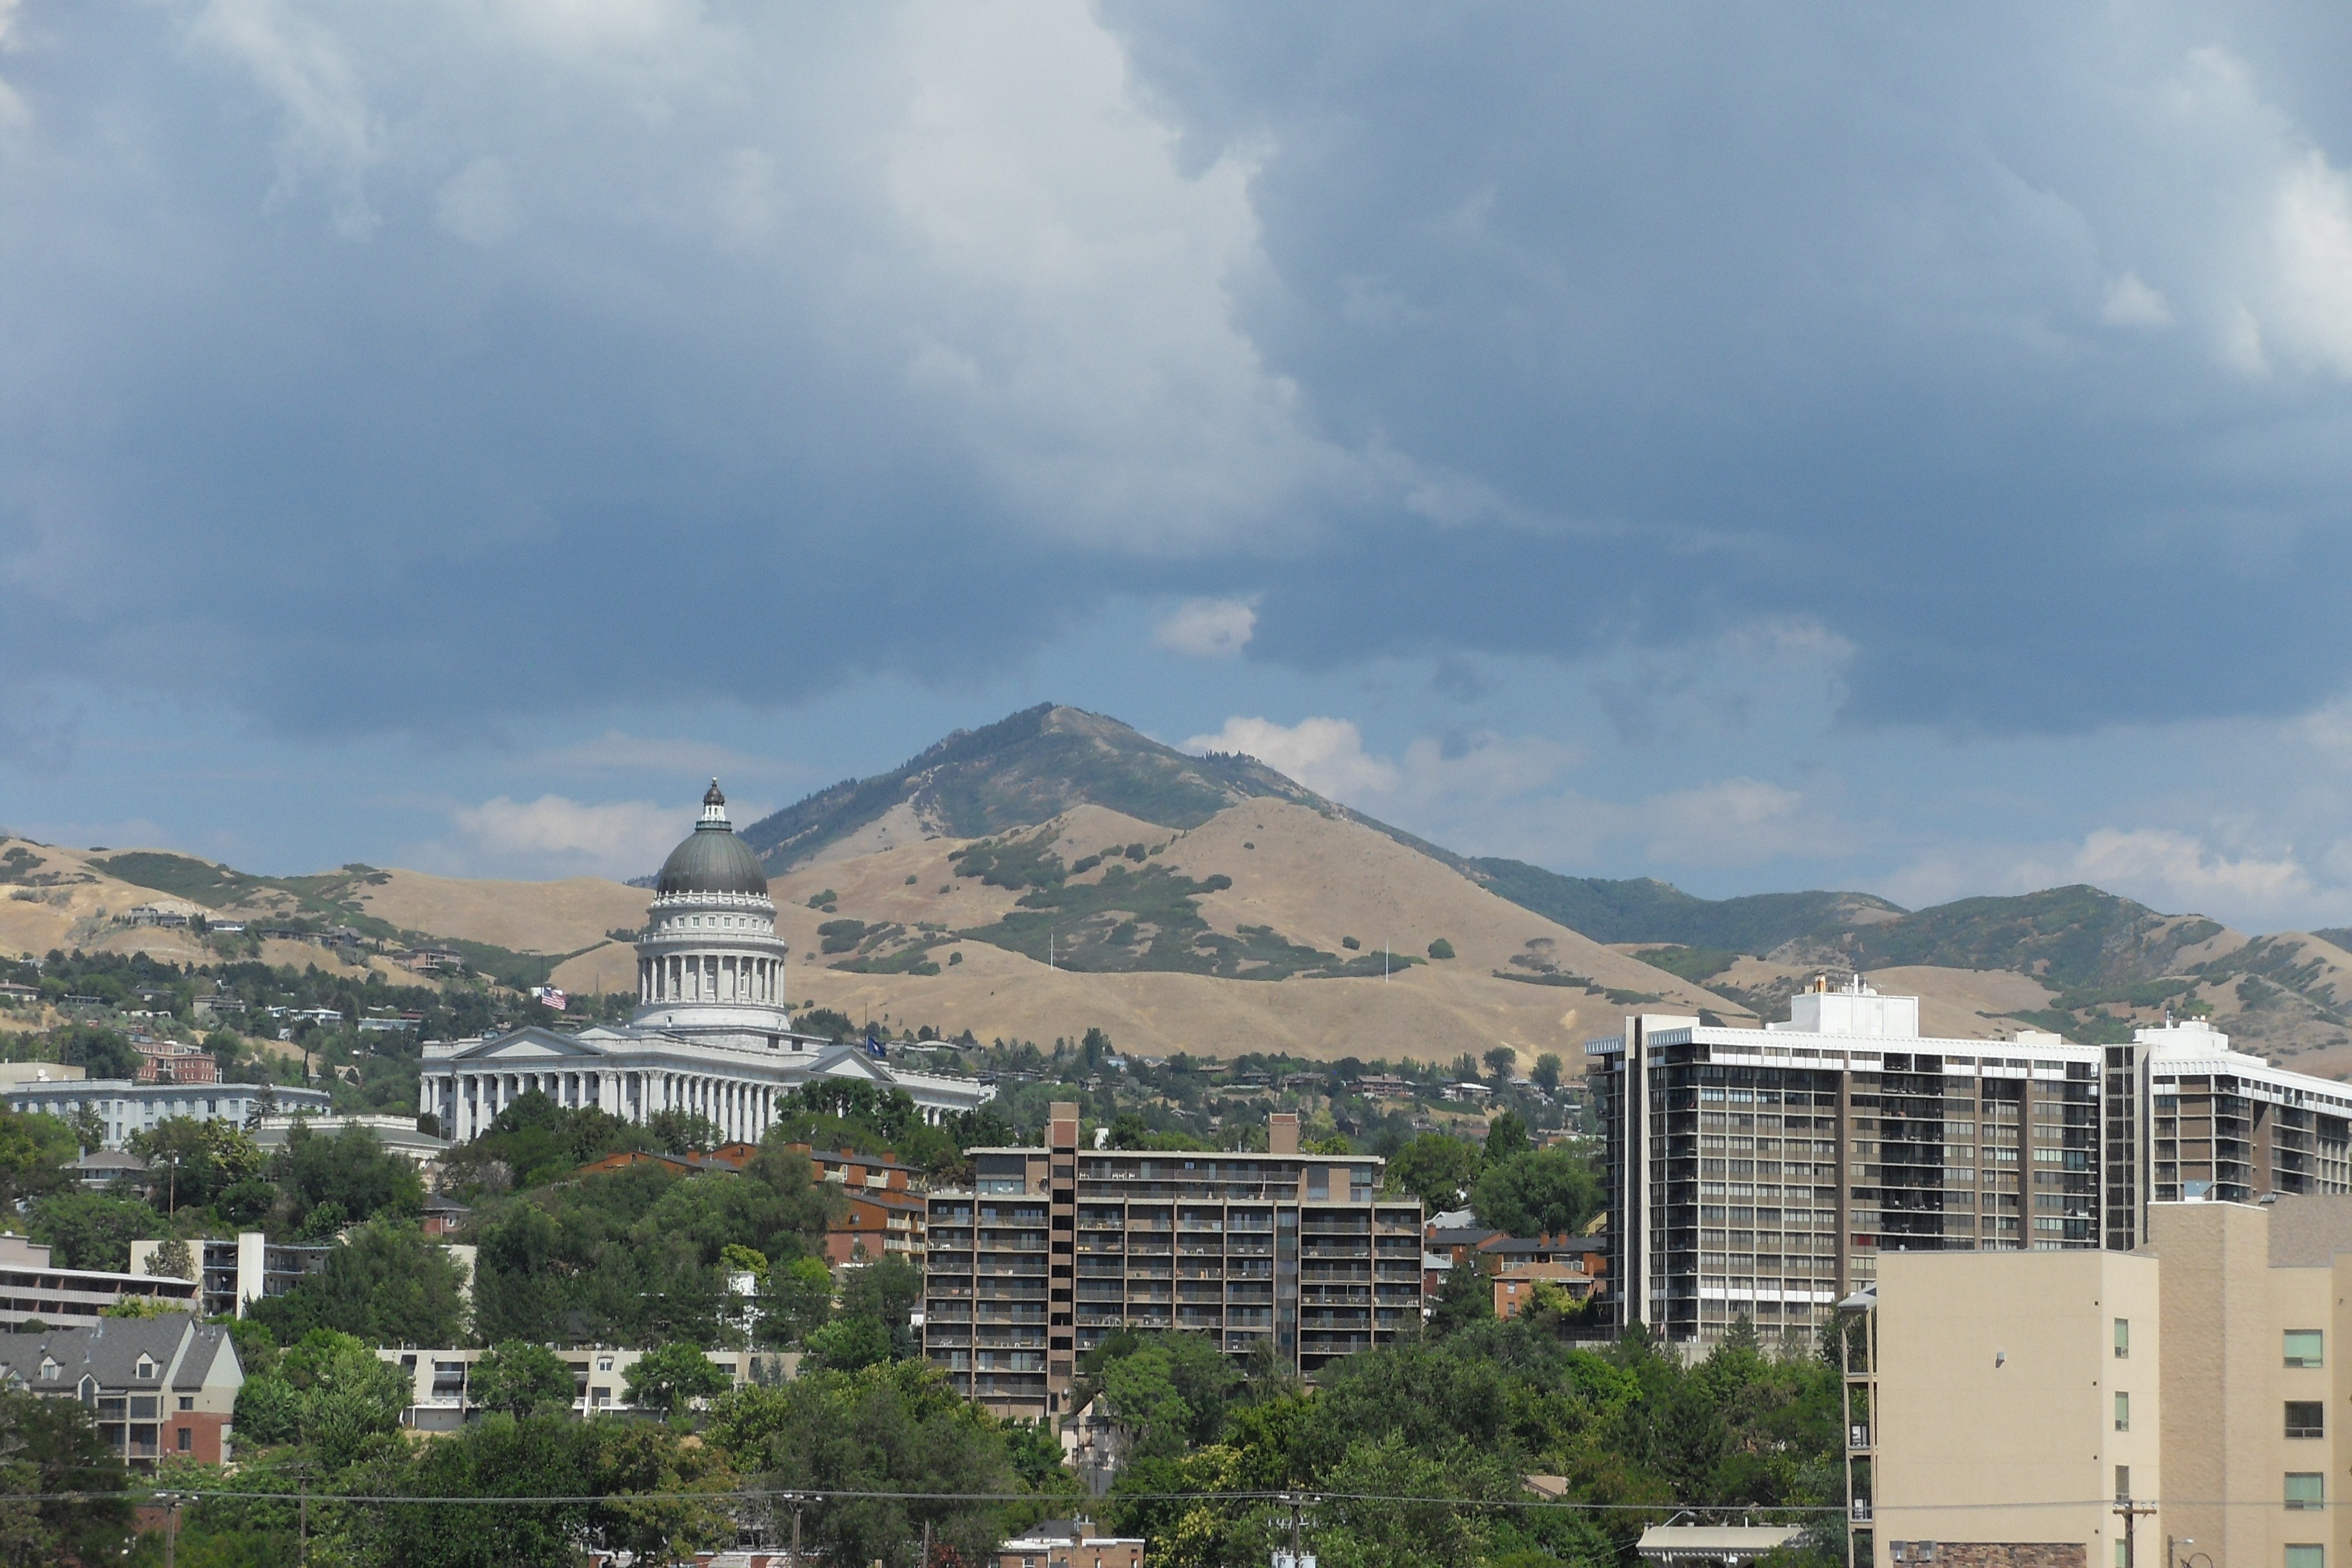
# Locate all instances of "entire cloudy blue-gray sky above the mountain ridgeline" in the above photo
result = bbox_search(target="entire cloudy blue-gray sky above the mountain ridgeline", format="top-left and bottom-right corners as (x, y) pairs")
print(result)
(0, 0), (2352, 928)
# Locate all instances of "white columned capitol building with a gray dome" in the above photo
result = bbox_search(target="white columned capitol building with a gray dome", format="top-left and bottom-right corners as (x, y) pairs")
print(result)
(416, 778), (997, 1142)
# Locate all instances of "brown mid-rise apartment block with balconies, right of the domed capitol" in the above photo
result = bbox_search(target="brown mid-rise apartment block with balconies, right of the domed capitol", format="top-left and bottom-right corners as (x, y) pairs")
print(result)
(922, 1105), (1420, 1420)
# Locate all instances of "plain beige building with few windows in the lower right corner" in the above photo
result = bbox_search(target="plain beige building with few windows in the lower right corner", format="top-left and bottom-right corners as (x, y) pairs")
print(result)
(1848, 1197), (2352, 1568)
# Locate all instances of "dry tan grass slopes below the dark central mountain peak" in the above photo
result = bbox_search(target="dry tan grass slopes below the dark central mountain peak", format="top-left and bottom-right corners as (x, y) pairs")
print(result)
(743, 799), (1745, 1060)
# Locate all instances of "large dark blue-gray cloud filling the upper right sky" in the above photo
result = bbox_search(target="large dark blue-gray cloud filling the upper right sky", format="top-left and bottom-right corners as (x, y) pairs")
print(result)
(1115, 5), (2352, 729)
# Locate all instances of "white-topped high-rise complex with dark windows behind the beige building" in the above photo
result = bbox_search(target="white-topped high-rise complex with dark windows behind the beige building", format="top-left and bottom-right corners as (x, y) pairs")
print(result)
(1585, 978), (2352, 1342)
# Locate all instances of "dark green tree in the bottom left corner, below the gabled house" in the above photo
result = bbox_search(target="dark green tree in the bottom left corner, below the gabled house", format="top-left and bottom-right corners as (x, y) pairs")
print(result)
(0, 1392), (132, 1568)
